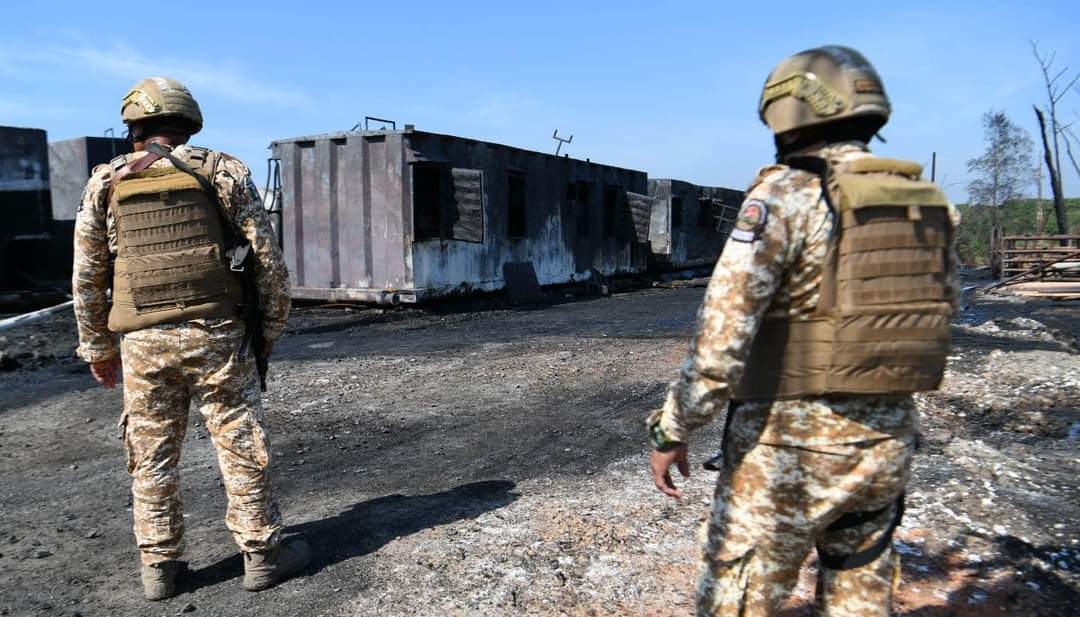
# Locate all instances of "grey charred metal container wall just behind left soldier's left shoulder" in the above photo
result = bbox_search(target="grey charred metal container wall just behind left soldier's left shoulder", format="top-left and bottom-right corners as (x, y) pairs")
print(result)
(49, 137), (131, 220)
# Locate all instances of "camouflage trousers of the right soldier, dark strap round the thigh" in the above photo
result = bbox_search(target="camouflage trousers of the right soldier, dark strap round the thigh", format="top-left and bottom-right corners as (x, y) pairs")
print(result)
(697, 417), (915, 617)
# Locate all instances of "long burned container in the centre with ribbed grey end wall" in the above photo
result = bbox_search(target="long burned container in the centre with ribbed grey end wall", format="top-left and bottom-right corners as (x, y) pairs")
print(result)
(271, 125), (649, 303)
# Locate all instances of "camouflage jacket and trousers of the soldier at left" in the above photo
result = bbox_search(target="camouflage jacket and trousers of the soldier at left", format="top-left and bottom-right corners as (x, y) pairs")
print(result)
(72, 146), (289, 564)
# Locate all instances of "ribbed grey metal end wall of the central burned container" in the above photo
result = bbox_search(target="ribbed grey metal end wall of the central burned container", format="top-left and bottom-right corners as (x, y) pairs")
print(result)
(271, 131), (413, 301)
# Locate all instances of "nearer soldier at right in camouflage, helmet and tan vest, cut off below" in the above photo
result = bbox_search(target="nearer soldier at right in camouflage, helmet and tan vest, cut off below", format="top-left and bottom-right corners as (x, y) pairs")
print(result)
(648, 46), (959, 617)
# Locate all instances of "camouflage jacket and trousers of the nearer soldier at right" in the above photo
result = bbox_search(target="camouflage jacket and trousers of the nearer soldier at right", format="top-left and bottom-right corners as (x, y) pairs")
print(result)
(649, 142), (959, 616)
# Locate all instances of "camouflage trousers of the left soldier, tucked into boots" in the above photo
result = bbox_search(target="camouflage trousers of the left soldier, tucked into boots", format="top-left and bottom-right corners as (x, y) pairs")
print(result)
(121, 319), (282, 564)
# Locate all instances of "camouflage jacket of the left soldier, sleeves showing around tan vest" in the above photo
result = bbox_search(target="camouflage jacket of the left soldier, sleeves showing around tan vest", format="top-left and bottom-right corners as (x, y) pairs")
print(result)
(71, 145), (289, 362)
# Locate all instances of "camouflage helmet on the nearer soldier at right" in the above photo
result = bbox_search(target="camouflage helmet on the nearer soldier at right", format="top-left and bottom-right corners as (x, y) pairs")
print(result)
(757, 45), (891, 135)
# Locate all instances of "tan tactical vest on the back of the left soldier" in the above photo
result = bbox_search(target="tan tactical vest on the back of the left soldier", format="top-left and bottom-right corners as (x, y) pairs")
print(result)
(109, 148), (242, 333)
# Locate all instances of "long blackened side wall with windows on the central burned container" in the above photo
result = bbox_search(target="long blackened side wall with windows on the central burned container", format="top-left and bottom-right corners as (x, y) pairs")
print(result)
(406, 132), (648, 295)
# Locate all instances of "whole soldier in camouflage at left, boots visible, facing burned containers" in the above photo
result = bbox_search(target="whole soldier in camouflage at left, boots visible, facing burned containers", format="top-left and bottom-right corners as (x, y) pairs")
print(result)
(72, 77), (310, 600)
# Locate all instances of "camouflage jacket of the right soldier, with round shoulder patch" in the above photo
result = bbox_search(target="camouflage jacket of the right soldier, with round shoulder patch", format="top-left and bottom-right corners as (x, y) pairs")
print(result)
(647, 142), (959, 446)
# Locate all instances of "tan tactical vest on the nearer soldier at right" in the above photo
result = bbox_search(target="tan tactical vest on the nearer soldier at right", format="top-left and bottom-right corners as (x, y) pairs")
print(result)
(734, 158), (953, 400)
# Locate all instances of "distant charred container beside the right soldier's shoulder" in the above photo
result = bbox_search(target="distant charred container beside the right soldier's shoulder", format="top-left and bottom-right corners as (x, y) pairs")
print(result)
(649, 179), (743, 269)
